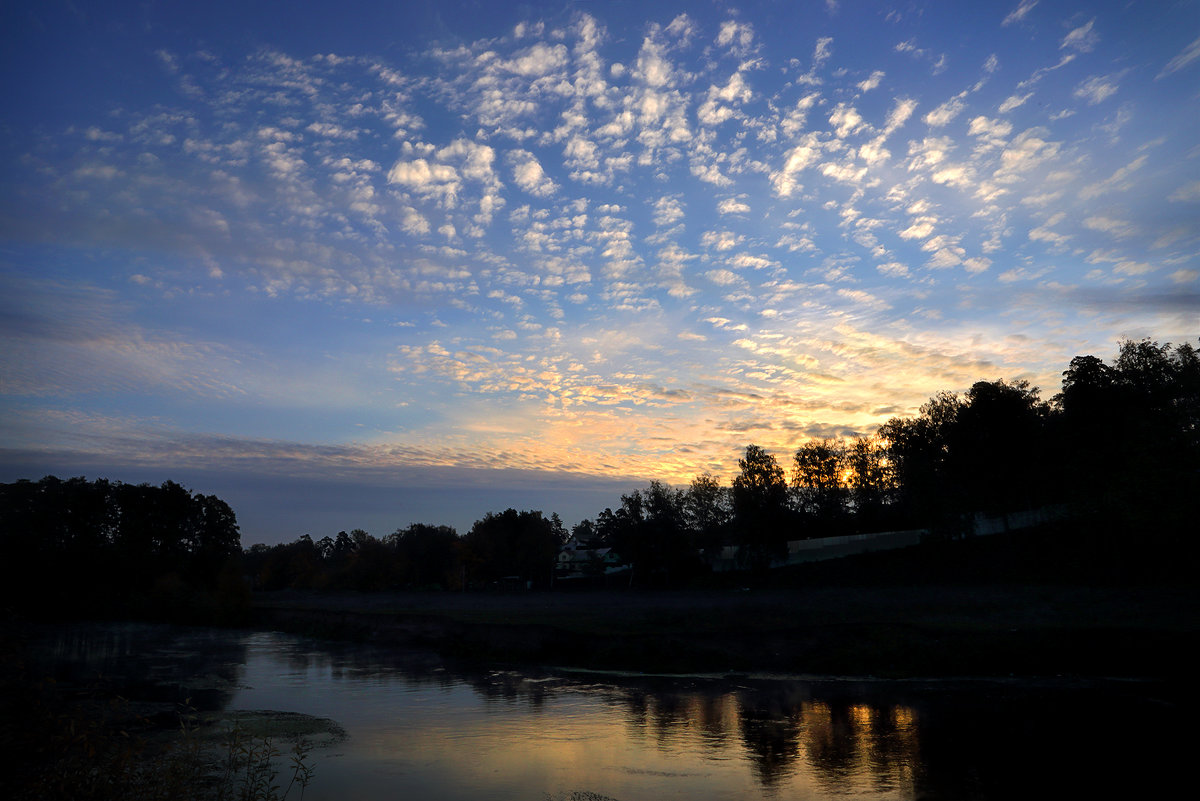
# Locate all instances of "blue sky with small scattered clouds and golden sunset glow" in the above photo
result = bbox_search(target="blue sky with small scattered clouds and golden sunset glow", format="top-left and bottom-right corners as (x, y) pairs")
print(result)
(0, 0), (1200, 544)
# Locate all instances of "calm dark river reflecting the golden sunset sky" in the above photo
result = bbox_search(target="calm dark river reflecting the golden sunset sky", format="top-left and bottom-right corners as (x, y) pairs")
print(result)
(25, 625), (1195, 801)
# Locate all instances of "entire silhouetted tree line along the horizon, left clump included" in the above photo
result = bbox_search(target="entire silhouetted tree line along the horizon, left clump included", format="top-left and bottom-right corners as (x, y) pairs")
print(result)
(0, 339), (1200, 600)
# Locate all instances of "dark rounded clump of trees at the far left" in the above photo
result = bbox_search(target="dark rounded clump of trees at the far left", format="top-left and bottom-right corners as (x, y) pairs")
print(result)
(0, 476), (242, 616)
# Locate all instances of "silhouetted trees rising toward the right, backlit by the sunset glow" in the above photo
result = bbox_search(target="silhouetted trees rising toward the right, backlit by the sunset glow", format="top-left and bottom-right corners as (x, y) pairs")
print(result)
(238, 339), (1200, 589)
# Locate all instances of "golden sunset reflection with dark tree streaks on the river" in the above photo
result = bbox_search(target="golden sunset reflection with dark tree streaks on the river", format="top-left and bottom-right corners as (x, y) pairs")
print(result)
(343, 671), (919, 800)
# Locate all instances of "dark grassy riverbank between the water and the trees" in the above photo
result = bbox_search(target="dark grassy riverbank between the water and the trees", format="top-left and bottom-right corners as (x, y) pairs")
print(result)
(252, 585), (1200, 680)
